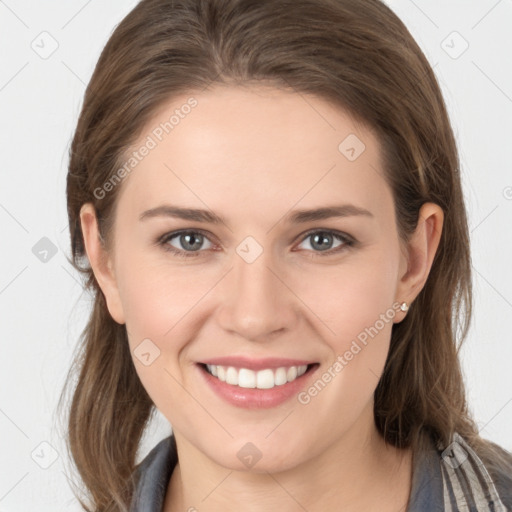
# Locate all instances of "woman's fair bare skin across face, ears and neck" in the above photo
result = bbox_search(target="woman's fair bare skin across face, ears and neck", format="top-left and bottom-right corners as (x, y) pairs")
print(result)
(80, 86), (443, 512)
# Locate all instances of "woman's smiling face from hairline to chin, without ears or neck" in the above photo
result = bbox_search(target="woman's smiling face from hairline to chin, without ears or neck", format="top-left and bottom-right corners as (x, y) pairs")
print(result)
(82, 87), (438, 471)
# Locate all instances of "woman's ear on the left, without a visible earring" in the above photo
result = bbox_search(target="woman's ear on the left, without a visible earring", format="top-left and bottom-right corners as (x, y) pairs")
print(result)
(80, 203), (125, 324)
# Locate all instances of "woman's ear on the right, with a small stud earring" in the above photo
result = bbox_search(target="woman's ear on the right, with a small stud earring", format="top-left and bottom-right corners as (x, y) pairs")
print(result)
(396, 203), (444, 319)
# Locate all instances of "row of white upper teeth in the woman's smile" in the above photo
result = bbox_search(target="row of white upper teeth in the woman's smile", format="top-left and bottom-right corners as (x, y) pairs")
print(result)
(206, 364), (308, 389)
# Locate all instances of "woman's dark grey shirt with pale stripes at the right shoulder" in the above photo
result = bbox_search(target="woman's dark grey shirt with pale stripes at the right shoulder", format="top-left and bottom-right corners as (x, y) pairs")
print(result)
(130, 433), (512, 512)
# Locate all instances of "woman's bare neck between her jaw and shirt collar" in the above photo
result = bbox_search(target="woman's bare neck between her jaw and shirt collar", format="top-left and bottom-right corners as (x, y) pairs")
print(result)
(163, 410), (412, 512)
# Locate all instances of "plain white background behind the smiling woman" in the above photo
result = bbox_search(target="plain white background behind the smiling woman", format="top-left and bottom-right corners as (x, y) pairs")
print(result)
(0, 0), (512, 512)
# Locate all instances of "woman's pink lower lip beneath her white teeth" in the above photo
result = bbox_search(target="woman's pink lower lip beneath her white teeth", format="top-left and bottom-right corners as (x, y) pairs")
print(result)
(196, 363), (319, 409)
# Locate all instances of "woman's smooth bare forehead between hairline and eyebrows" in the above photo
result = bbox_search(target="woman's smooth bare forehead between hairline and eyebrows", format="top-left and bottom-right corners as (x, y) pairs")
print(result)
(114, 86), (391, 224)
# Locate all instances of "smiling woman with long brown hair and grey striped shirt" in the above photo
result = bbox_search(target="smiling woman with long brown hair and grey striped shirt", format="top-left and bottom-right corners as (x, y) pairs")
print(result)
(60, 0), (512, 512)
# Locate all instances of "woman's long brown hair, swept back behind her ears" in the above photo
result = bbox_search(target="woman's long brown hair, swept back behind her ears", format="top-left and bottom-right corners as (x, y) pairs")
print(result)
(59, 0), (510, 511)
